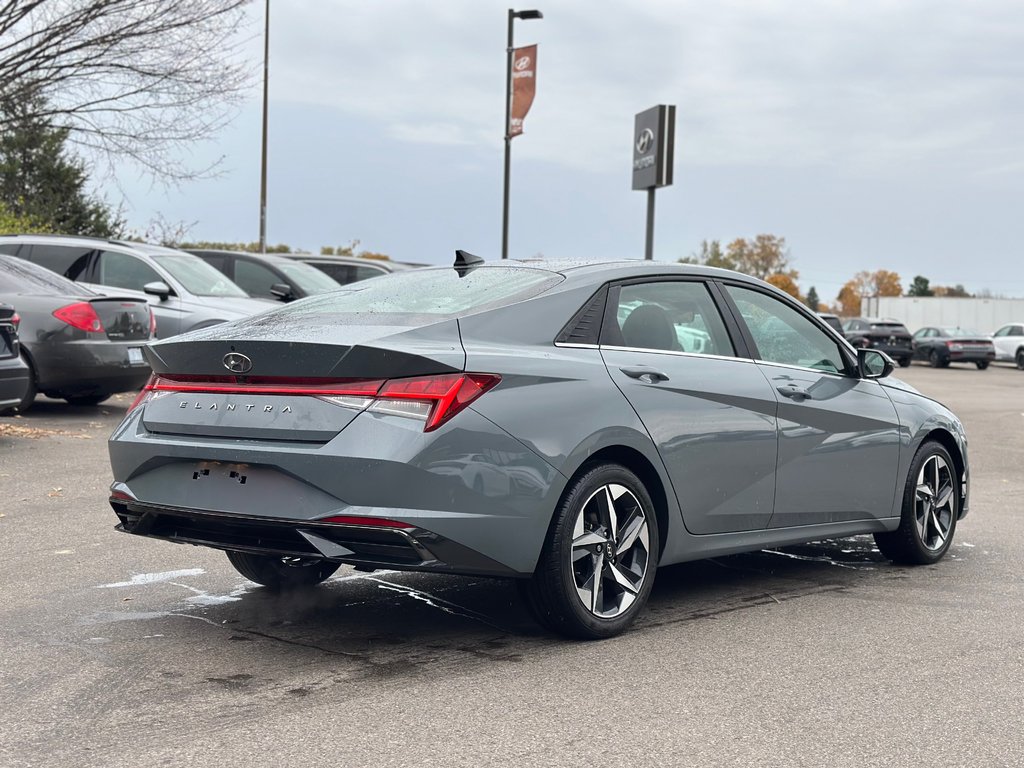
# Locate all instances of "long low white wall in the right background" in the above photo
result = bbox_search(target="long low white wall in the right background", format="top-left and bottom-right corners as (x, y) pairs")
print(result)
(860, 296), (1024, 334)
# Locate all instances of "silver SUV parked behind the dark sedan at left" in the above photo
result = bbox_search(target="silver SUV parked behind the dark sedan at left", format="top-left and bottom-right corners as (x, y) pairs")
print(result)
(0, 234), (274, 339)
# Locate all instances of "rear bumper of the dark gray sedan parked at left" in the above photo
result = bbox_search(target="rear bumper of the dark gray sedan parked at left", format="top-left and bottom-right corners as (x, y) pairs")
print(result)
(25, 340), (150, 395)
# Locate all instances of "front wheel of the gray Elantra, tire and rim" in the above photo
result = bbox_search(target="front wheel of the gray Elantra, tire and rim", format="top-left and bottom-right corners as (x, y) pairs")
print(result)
(874, 440), (961, 565)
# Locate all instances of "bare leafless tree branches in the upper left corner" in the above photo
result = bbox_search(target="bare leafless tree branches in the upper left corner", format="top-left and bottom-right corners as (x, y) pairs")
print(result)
(0, 0), (252, 180)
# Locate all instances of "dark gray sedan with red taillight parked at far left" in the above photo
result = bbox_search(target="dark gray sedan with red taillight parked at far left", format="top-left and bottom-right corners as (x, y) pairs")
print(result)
(0, 254), (155, 411)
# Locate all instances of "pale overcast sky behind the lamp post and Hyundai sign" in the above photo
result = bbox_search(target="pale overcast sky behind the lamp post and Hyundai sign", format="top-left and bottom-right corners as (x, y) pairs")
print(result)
(110, 0), (1024, 301)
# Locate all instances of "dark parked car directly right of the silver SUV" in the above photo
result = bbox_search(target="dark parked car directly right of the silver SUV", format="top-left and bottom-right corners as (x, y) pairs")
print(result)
(187, 249), (341, 301)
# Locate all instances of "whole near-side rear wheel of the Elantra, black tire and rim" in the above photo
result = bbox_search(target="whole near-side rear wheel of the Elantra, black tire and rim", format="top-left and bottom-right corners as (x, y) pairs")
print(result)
(519, 464), (660, 640)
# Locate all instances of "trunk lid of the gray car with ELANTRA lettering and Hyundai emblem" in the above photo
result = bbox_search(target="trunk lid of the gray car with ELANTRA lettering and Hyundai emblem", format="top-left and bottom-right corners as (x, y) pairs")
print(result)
(142, 321), (466, 442)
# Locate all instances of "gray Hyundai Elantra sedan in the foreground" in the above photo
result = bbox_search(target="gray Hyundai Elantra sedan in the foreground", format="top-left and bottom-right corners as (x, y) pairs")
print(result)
(110, 252), (969, 638)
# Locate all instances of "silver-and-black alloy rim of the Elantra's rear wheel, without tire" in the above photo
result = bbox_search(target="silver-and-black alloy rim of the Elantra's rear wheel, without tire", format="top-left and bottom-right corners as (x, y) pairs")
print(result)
(571, 483), (651, 618)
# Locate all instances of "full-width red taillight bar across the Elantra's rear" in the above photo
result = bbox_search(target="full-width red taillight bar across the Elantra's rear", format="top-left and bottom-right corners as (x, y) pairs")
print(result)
(128, 374), (502, 432)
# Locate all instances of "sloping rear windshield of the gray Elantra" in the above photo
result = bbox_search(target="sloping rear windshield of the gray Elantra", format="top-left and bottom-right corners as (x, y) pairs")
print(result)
(270, 266), (562, 325)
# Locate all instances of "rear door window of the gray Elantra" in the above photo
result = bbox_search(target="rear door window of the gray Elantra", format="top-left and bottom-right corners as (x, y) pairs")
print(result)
(601, 281), (735, 356)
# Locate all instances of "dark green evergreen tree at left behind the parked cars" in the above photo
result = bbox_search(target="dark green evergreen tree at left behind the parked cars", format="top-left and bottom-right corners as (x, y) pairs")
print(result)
(0, 94), (124, 238)
